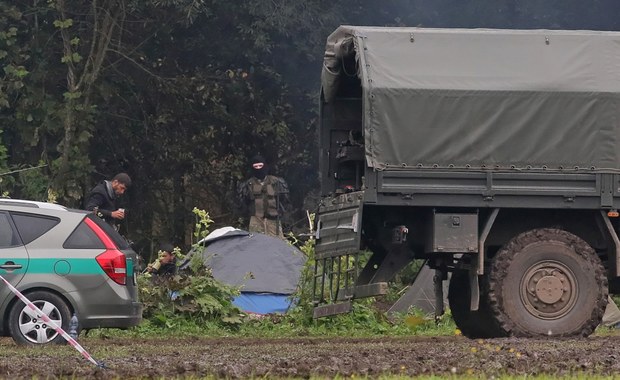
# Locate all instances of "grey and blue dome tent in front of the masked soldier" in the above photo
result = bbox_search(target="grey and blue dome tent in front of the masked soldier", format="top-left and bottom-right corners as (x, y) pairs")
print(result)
(182, 227), (306, 314)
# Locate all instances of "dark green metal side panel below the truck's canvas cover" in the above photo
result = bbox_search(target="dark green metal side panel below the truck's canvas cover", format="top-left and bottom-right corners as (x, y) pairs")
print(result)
(376, 169), (620, 209)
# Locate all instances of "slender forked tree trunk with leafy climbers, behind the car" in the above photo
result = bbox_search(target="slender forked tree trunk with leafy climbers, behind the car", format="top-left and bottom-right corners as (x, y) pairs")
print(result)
(48, 0), (126, 198)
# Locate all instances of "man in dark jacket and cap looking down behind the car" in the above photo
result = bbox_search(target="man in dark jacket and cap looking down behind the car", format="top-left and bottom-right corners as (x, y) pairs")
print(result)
(84, 173), (131, 229)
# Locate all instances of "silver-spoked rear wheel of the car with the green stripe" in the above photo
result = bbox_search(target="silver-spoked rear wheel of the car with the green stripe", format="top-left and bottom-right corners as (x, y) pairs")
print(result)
(8, 291), (71, 345)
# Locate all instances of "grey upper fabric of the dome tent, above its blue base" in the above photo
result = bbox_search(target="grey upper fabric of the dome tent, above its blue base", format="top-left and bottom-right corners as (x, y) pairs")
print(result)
(189, 229), (306, 294)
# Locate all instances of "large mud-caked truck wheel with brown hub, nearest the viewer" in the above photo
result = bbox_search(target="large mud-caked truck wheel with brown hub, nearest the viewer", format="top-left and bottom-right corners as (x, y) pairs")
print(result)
(488, 228), (608, 337)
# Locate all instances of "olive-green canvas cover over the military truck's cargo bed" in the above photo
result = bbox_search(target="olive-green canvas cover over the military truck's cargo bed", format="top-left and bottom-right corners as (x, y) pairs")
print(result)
(321, 26), (620, 170)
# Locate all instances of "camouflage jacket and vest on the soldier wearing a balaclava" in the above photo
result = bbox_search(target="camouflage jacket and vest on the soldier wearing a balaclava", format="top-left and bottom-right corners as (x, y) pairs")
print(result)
(238, 175), (289, 219)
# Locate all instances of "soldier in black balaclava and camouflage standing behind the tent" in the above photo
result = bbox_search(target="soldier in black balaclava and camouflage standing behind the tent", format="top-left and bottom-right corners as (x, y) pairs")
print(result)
(238, 155), (288, 237)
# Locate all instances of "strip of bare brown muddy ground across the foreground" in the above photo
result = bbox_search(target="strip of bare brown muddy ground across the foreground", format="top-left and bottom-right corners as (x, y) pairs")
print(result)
(0, 336), (620, 379)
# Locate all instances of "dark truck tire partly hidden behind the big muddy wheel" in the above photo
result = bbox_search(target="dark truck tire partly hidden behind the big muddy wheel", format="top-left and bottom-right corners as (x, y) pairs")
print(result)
(448, 270), (505, 338)
